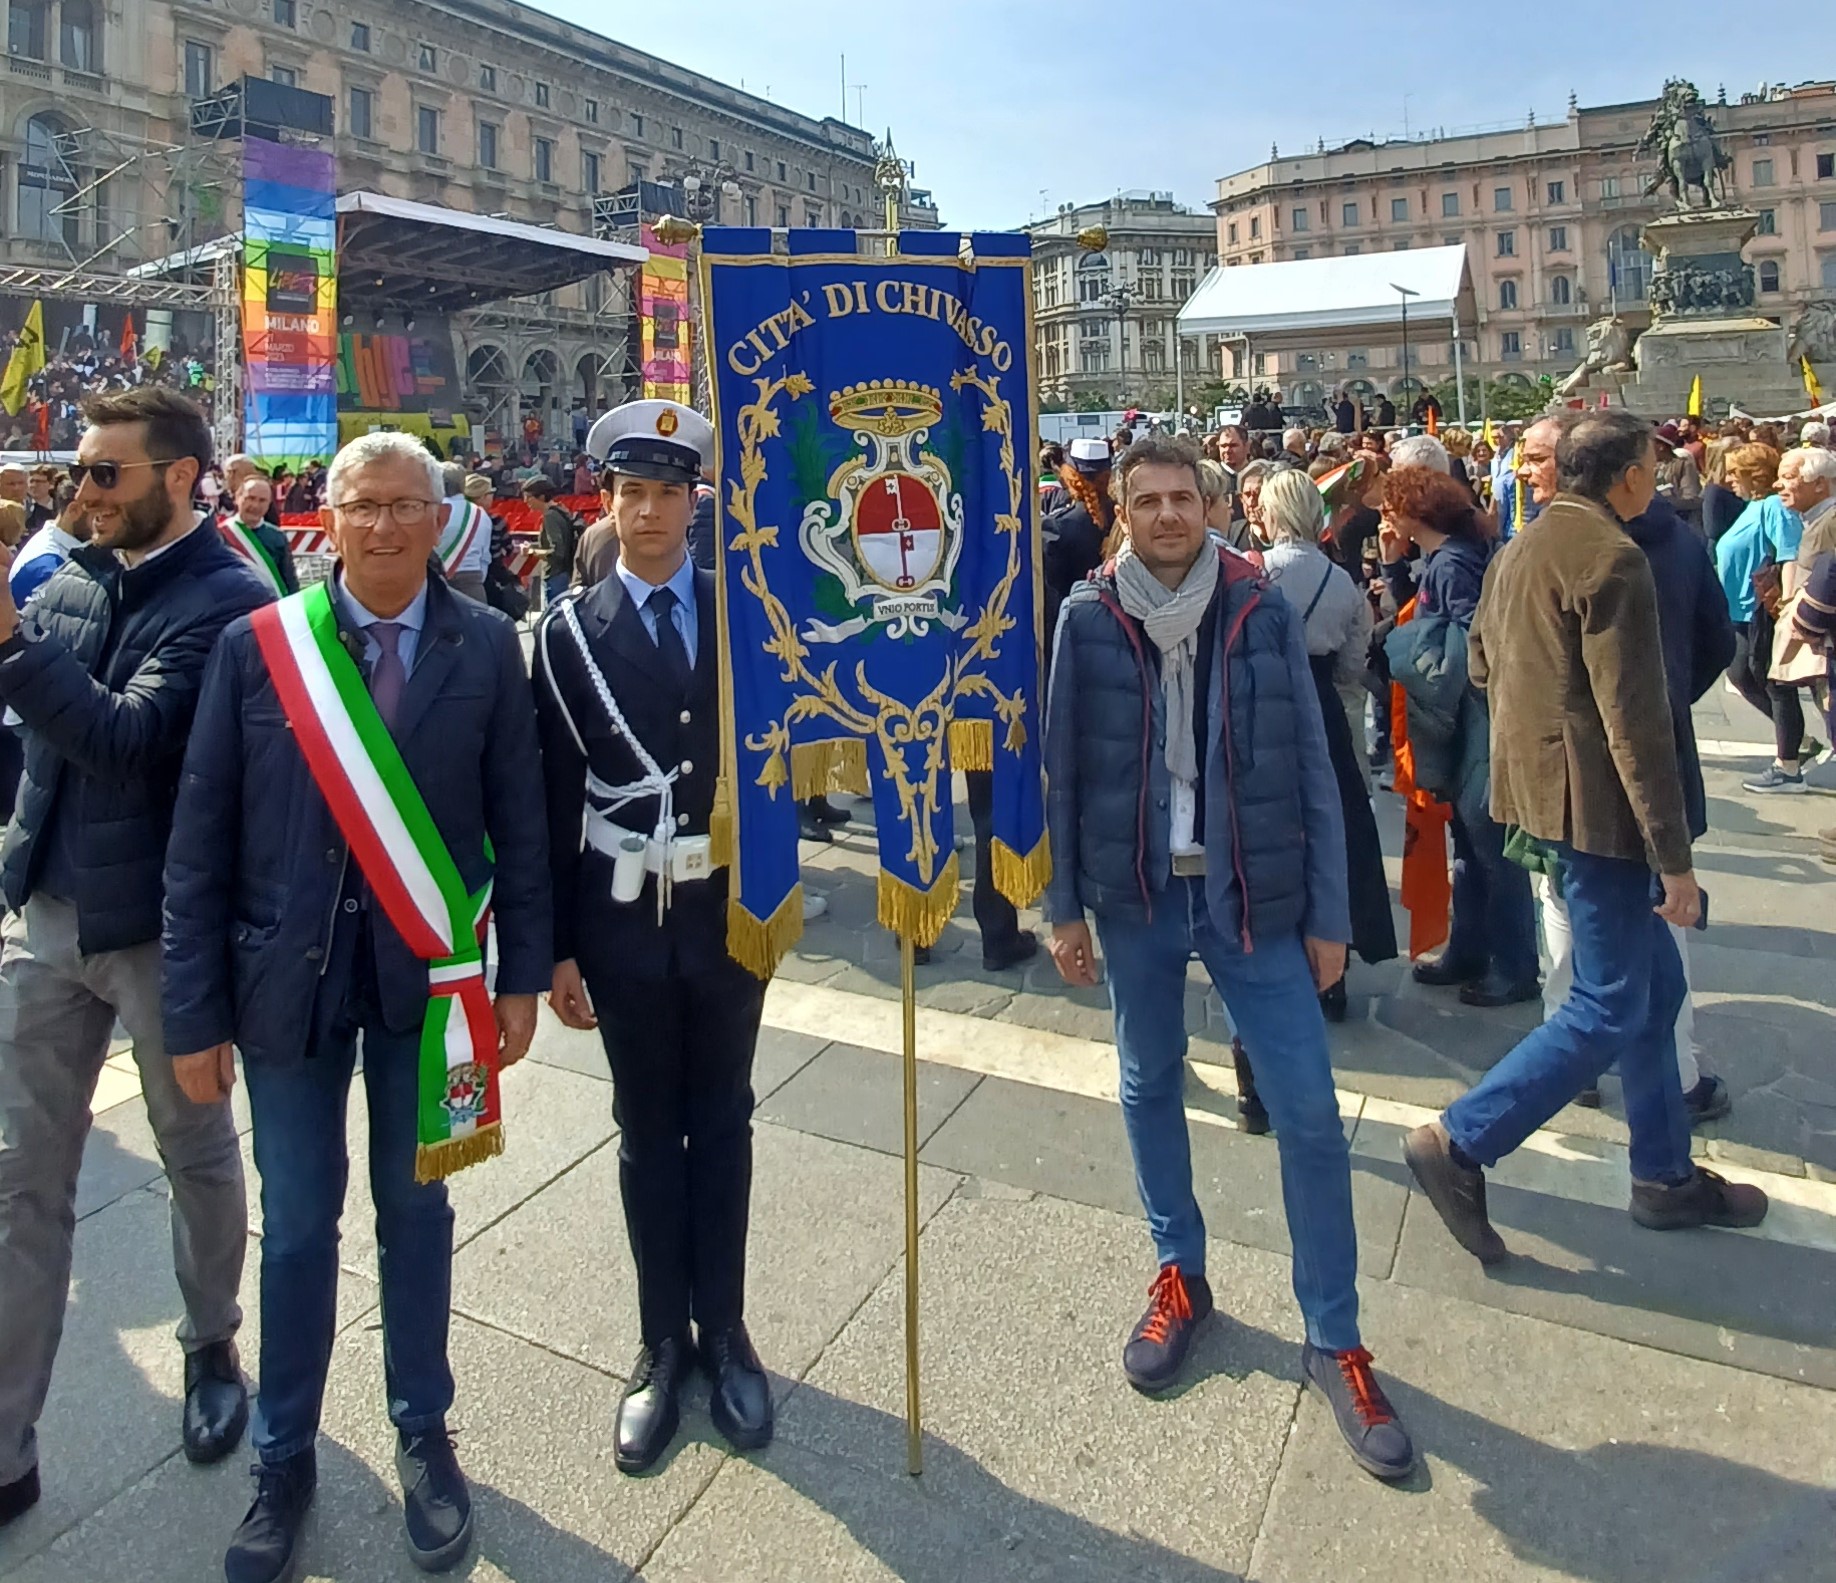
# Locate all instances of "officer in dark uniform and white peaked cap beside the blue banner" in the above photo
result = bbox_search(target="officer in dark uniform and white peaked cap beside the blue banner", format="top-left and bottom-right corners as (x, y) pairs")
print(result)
(534, 400), (771, 1473)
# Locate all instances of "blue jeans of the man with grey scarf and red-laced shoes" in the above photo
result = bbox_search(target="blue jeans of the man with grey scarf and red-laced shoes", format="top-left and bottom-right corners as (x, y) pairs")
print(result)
(1096, 878), (1359, 1352)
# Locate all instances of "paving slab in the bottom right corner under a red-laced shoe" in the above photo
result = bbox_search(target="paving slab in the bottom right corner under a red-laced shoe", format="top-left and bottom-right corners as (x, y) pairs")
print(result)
(1248, 1284), (1836, 1583)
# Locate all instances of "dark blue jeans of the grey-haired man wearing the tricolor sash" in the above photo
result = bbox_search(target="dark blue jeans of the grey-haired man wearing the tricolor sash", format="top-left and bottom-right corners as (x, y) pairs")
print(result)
(244, 1016), (453, 1464)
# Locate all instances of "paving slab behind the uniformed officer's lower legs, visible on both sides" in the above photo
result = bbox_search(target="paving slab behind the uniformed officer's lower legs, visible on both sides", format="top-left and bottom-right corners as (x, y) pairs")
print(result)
(453, 1122), (957, 1379)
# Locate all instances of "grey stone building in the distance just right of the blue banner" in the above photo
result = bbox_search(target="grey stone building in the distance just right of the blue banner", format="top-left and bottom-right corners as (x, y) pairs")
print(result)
(1026, 193), (1217, 408)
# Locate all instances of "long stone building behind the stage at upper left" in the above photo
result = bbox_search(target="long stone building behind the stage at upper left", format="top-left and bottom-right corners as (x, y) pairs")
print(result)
(0, 0), (936, 446)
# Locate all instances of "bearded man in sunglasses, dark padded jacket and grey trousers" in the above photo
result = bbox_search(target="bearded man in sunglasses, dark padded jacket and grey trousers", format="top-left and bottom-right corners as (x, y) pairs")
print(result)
(0, 386), (266, 1526)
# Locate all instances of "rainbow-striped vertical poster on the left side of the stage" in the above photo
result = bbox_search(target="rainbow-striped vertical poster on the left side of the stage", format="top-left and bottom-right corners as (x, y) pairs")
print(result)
(242, 138), (338, 468)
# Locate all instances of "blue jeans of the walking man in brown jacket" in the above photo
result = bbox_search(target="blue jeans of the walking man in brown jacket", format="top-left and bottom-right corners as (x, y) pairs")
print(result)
(1441, 847), (1695, 1183)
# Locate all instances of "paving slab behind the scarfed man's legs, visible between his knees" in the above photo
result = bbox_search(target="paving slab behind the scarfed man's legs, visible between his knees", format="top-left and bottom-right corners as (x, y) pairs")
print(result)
(922, 1078), (1406, 1276)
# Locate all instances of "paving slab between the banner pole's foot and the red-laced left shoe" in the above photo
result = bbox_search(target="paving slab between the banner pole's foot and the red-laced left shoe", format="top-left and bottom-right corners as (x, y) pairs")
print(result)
(782, 1196), (1298, 1577)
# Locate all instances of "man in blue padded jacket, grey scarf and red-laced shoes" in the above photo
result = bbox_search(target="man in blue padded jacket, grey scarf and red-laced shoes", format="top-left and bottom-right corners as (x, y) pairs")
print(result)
(1045, 437), (1416, 1478)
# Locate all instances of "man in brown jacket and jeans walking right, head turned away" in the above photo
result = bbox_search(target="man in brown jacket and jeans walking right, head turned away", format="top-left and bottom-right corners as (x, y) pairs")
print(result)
(1403, 411), (1766, 1263)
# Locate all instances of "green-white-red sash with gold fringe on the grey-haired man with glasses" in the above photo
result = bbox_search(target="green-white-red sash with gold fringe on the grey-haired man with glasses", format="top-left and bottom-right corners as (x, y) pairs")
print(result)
(250, 582), (503, 1181)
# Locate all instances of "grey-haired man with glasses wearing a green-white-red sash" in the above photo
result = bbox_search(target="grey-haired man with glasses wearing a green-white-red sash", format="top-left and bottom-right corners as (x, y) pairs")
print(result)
(165, 433), (553, 1583)
